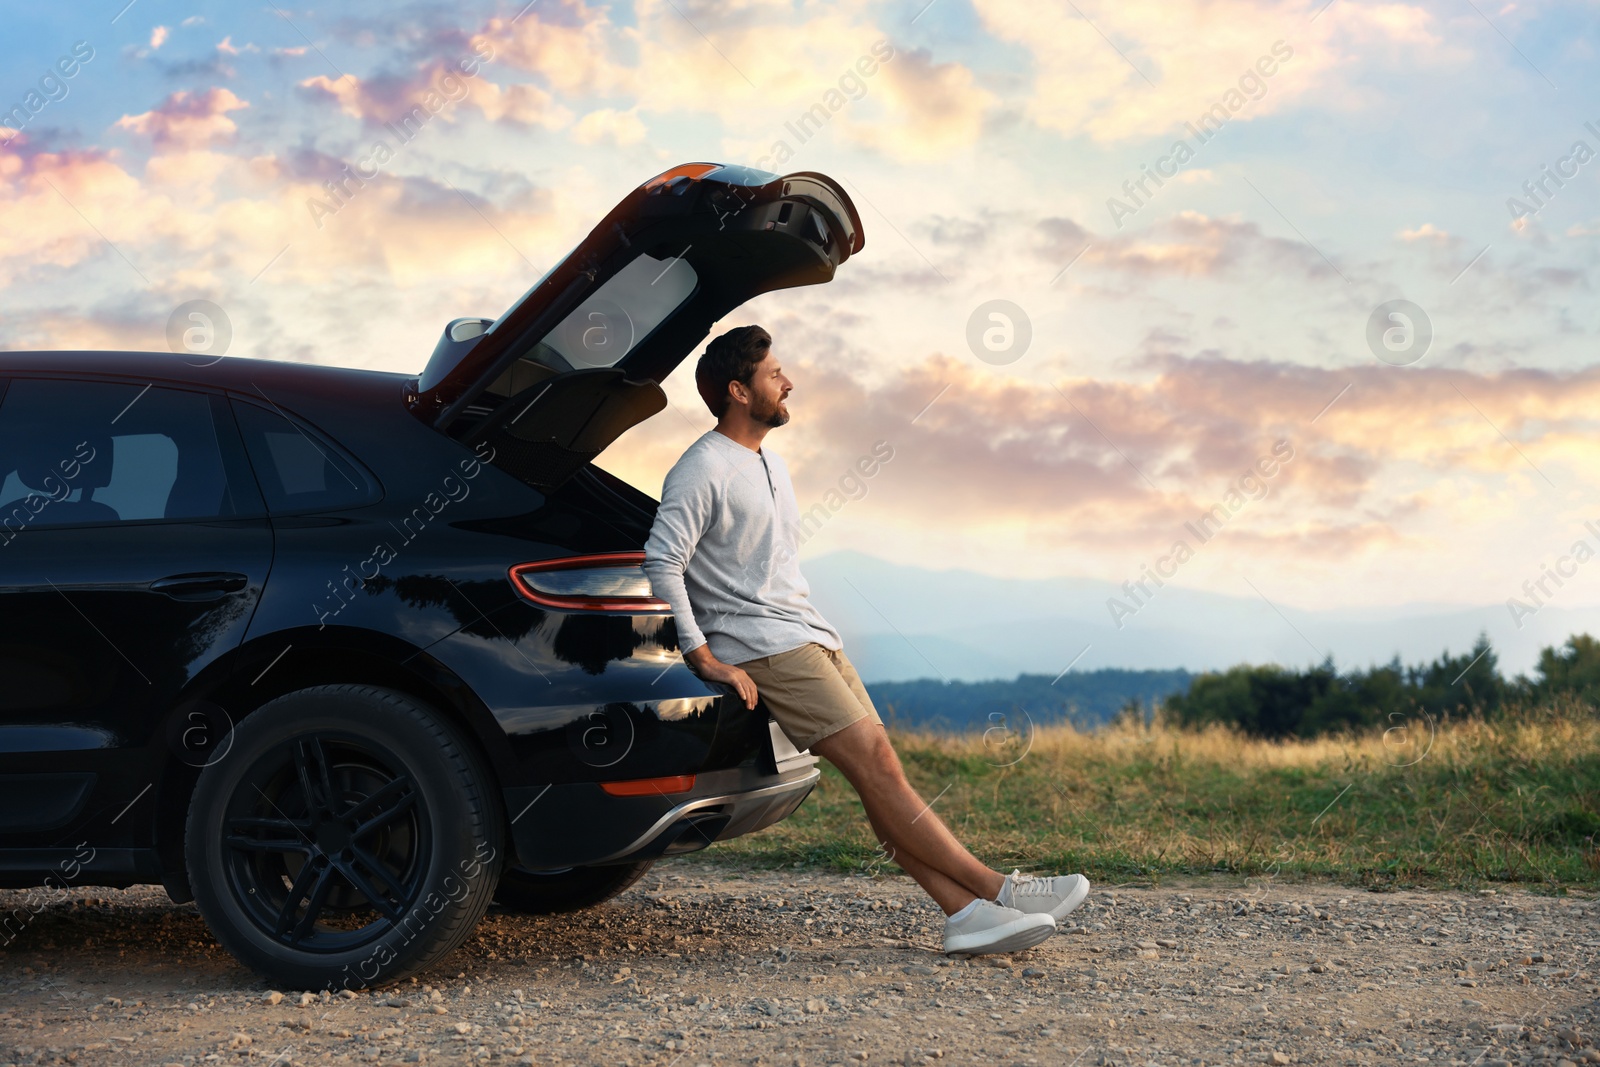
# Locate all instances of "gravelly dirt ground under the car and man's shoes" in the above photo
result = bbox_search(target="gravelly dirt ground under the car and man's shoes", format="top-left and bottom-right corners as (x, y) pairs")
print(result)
(0, 861), (1600, 1067)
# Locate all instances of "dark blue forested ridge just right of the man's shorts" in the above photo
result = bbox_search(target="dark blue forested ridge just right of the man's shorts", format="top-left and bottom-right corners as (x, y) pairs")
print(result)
(867, 669), (1194, 733)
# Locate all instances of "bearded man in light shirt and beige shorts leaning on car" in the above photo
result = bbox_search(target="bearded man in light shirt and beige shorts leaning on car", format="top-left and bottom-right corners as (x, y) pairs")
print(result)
(645, 326), (1090, 953)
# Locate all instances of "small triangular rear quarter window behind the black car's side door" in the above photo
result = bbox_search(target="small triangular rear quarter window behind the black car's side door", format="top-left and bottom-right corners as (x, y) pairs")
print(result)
(234, 400), (381, 515)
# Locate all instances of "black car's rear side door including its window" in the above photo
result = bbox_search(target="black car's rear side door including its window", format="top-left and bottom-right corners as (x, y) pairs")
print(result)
(0, 376), (272, 867)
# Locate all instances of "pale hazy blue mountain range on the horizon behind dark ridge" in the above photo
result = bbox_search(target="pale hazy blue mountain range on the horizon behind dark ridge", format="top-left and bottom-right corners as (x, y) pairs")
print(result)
(803, 552), (1600, 683)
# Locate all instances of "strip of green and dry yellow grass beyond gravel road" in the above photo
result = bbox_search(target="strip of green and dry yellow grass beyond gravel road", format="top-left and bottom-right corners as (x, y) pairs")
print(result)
(701, 705), (1600, 891)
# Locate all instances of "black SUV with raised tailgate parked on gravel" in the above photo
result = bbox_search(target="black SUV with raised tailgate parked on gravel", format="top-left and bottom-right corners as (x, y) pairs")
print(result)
(0, 163), (862, 989)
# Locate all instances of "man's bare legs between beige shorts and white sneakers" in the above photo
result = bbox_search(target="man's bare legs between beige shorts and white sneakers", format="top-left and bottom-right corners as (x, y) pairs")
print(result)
(811, 720), (1005, 915)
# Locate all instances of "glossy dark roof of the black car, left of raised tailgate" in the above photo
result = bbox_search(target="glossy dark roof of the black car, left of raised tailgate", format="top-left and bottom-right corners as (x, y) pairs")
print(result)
(0, 352), (414, 395)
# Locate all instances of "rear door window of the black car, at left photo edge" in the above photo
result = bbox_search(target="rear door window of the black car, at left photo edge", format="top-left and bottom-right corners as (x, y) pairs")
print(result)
(0, 378), (240, 531)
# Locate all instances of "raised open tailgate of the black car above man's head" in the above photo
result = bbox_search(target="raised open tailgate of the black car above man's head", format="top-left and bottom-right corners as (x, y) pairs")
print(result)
(411, 163), (864, 488)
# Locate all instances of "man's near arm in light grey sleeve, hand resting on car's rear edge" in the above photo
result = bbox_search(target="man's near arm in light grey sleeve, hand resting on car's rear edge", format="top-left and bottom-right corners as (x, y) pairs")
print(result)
(645, 460), (755, 709)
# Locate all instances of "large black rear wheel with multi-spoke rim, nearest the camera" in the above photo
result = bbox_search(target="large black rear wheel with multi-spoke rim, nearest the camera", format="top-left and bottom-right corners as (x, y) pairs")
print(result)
(184, 685), (504, 989)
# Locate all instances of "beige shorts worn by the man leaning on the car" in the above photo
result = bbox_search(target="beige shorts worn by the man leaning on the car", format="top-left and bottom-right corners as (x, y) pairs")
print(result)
(739, 643), (883, 750)
